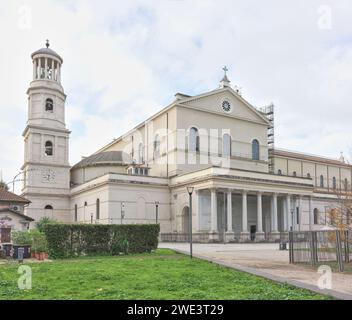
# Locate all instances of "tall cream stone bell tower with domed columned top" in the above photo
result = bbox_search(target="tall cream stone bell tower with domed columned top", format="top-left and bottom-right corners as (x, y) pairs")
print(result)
(21, 40), (71, 222)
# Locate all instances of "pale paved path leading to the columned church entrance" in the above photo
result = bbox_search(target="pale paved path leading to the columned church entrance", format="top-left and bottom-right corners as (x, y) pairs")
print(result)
(159, 243), (352, 300)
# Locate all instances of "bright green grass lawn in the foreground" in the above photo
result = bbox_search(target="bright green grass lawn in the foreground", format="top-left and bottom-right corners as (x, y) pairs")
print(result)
(0, 249), (328, 299)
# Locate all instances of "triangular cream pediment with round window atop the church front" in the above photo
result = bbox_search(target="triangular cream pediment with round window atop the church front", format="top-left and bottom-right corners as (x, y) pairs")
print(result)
(178, 87), (268, 124)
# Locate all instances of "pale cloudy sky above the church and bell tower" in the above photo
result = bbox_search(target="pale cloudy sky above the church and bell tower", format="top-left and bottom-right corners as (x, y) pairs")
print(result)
(0, 0), (352, 190)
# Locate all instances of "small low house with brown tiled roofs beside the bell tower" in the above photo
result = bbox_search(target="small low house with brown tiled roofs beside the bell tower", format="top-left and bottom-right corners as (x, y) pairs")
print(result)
(0, 189), (34, 234)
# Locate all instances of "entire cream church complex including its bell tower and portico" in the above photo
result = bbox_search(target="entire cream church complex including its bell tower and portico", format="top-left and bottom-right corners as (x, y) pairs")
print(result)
(22, 44), (352, 242)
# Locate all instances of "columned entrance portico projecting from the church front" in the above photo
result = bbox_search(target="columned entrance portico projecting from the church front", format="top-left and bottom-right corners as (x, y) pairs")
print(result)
(169, 168), (312, 242)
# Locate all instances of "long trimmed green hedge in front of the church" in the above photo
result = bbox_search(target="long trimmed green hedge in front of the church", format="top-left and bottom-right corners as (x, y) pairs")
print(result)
(43, 223), (160, 259)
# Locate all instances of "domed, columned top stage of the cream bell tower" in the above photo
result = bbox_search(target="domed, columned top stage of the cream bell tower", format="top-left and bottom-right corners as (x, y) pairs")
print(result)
(31, 40), (63, 83)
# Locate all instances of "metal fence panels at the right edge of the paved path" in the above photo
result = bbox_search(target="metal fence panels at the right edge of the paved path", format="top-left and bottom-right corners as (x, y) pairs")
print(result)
(289, 230), (352, 271)
